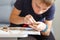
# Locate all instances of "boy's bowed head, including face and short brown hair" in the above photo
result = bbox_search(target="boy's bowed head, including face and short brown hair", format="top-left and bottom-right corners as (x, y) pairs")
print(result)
(36, 0), (55, 14)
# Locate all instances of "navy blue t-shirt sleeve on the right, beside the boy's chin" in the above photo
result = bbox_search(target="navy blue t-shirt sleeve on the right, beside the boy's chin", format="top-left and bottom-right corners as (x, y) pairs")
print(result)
(45, 5), (55, 20)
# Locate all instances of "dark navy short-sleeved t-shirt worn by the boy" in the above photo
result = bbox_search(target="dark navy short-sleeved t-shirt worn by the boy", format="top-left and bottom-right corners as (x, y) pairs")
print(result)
(9, 0), (55, 26)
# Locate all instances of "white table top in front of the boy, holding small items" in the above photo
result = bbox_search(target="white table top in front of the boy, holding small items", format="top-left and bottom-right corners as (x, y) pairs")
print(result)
(0, 28), (40, 37)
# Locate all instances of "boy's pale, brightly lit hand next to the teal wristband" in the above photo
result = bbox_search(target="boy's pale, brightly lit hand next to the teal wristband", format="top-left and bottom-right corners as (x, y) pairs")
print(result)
(29, 22), (46, 31)
